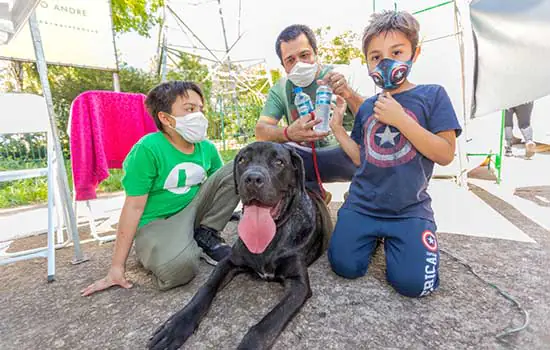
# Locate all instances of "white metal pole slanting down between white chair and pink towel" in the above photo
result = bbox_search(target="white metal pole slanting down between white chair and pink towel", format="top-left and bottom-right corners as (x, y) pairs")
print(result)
(29, 11), (87, 264)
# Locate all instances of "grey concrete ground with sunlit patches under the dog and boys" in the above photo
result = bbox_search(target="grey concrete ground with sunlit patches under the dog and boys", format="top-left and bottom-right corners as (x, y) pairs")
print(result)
(0, 115), (550, 350)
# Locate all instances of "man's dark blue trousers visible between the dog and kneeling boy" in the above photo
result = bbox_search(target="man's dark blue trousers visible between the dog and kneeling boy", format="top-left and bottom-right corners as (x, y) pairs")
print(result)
(286, 143), (357, 192)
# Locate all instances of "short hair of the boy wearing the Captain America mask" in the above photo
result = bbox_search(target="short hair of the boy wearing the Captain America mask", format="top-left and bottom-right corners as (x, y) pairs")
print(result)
(363, 10), (420, 57)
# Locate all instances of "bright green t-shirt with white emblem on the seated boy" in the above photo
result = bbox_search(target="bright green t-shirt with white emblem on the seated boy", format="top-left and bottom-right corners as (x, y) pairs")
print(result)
(122, 132), (223, 227)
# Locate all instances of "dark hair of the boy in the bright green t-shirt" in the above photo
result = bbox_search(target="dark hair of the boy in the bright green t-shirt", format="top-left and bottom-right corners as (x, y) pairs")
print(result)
(145, 80), (204, 131)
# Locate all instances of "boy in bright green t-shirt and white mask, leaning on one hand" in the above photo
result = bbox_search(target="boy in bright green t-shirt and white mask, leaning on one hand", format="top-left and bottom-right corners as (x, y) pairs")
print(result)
(82, 81), (239, 296)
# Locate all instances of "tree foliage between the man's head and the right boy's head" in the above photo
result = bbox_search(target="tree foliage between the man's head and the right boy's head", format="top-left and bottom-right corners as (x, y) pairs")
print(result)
(315, 26), (365, 64)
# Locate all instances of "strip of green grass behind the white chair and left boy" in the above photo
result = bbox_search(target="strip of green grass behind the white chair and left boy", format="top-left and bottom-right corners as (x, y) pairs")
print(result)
(0, 150), (242, 209)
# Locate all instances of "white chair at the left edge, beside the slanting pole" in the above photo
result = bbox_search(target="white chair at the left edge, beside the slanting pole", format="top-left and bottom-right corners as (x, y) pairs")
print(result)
(0, 93), (64, 282)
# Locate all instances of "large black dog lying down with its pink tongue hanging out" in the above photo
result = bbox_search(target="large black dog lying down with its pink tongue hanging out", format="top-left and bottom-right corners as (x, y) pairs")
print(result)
(149, 142), (332, 350)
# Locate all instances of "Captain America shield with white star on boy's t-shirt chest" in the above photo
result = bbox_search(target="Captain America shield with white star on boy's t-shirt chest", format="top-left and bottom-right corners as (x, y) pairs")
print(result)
(364, 109), (418, 168)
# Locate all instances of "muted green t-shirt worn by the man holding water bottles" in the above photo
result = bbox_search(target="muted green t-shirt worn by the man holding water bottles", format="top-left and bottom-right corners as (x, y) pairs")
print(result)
(261, 65), (354, 148)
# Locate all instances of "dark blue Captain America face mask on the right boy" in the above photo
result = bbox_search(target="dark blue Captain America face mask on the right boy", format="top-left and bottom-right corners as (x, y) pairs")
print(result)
(369, 58), (412, 90)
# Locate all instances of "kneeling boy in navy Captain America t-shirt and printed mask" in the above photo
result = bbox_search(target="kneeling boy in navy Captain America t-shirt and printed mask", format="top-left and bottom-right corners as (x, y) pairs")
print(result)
(328, 11), (461, 297)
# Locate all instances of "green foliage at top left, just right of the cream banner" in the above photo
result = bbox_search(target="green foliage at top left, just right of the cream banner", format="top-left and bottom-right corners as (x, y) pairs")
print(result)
(111, 0), (164, 37)
